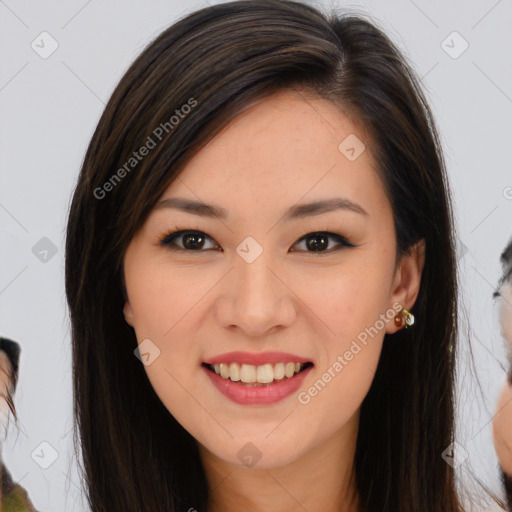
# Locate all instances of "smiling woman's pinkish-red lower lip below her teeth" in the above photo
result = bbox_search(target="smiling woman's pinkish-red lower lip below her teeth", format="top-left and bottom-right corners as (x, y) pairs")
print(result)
(202, 366), (313, 405)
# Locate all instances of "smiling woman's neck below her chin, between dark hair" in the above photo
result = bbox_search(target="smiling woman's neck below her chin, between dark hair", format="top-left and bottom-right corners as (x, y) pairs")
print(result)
(200, 413), (359, 512)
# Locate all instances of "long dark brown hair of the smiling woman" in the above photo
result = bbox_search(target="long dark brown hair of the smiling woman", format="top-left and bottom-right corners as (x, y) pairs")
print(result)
(65, 0), (500, 512)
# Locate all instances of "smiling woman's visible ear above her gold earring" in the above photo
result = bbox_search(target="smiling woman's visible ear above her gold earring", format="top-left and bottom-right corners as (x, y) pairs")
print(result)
(386, 238), (426, 334)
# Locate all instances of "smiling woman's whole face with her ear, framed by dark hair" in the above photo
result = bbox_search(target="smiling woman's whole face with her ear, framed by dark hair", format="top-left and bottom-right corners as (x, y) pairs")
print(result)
(124, 91), (423, 468)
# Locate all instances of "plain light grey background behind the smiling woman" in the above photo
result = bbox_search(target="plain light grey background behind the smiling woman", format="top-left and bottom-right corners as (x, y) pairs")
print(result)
(0, 0), (512, 512)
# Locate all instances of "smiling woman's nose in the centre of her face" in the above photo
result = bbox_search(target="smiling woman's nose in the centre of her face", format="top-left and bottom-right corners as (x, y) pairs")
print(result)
(216, 251), (298, 337)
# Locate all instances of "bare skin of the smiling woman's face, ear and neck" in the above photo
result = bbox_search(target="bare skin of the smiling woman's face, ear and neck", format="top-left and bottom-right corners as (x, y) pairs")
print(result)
(124, 91), (425, 512)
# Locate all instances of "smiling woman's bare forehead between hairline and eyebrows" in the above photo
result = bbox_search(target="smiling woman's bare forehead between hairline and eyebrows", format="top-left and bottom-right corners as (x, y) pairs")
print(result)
(163, 90), (387, 220)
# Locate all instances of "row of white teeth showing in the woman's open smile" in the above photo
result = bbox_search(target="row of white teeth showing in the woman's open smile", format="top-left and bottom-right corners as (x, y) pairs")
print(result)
(202, 362), (314, 387)
